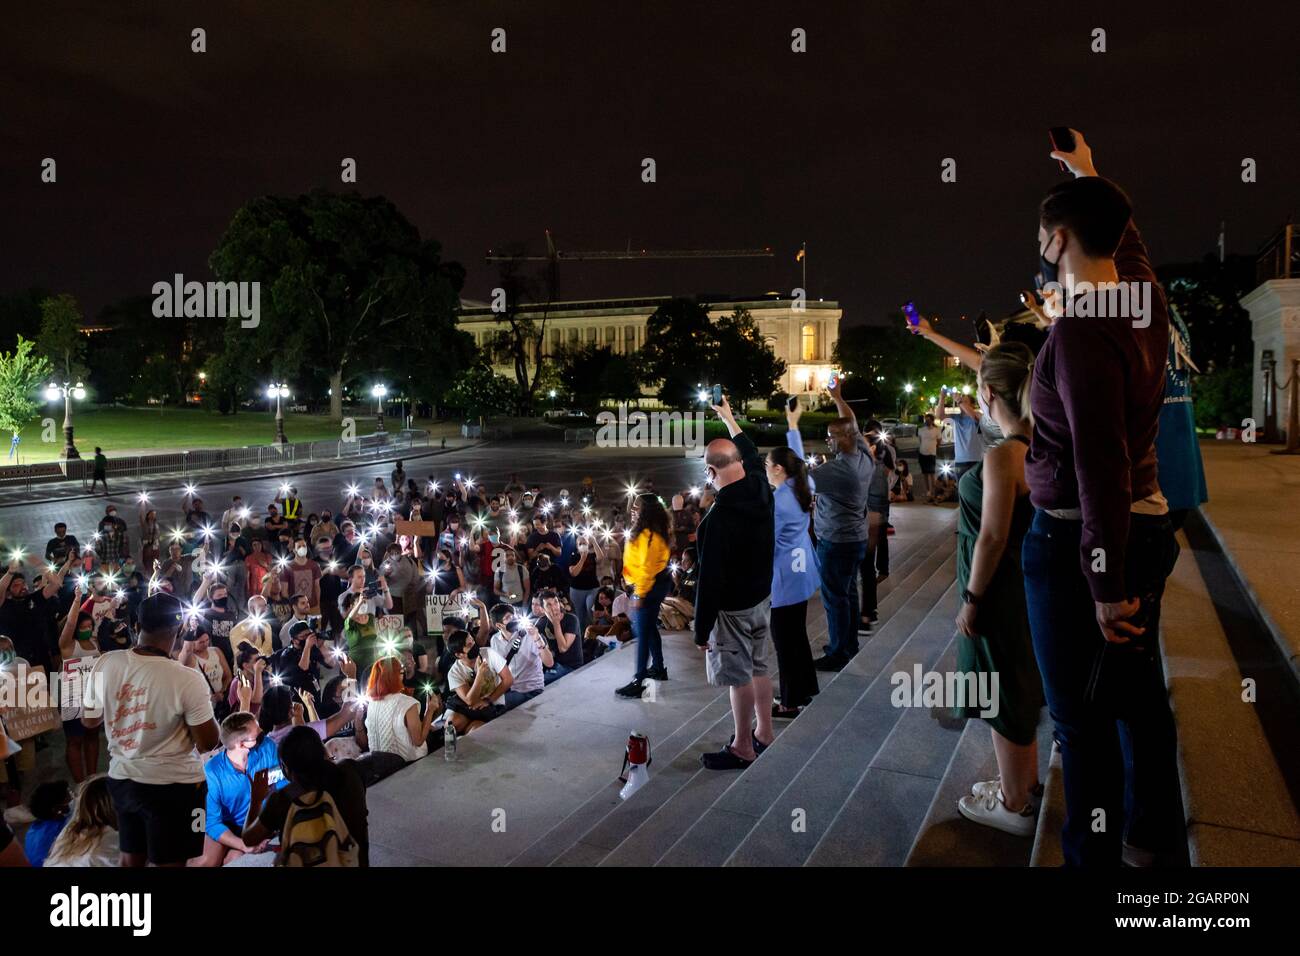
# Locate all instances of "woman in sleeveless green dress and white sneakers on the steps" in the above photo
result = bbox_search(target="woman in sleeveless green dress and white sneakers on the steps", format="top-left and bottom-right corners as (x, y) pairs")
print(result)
(957, 342), (1044, 836)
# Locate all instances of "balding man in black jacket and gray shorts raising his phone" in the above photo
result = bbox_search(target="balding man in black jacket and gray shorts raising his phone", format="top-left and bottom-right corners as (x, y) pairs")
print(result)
(694, 398), (775, 770)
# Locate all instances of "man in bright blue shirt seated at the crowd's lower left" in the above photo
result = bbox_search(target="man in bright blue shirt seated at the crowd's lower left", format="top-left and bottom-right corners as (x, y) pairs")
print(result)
(203, 710), (285, 866)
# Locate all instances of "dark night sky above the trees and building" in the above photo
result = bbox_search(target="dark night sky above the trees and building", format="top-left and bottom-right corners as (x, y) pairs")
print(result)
(0, 0), (1300, 332)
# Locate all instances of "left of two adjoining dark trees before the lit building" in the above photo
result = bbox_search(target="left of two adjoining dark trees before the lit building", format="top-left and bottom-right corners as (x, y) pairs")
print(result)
(638, 298), (718, 408)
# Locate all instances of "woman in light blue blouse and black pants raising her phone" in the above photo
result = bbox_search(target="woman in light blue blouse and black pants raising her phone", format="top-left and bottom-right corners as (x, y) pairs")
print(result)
(766, 402), (822, 719)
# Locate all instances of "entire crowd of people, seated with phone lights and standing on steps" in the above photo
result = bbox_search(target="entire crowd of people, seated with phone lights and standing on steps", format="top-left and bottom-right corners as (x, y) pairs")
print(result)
(0, 127), (1205, 866)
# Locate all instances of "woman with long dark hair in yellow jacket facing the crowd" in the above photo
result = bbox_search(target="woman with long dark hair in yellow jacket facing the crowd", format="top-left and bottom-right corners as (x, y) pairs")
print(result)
(615, 493), (672, 700)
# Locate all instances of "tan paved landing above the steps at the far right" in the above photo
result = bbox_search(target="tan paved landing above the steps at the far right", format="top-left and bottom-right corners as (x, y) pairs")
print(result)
(1201, 441), (1300, 679)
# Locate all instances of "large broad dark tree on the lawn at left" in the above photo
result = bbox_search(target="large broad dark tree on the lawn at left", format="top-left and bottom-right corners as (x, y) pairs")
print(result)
(209, 190), (464, 419)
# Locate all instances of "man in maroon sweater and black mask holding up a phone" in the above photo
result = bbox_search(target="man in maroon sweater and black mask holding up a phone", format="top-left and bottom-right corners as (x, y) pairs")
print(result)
(1022, 133), (1180, 866)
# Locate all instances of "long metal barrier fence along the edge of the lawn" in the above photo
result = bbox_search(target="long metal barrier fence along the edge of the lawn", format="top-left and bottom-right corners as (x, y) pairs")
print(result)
(0, 428), (430, 490)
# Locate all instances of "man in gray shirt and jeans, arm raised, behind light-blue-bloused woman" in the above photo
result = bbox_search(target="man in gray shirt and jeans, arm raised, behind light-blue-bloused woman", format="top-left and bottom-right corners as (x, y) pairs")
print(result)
(813, 378), (875, 671)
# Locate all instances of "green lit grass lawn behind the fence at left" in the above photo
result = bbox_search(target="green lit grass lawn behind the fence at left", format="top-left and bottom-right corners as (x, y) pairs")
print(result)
(0, 407), (429, 464)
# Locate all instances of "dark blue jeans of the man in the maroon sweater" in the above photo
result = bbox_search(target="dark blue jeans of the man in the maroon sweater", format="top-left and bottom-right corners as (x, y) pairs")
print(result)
(1022, 511), (1186, 866)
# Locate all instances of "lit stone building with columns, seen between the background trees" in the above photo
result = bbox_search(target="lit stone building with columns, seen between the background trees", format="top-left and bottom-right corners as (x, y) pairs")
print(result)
(459, 295), (842, 397)
